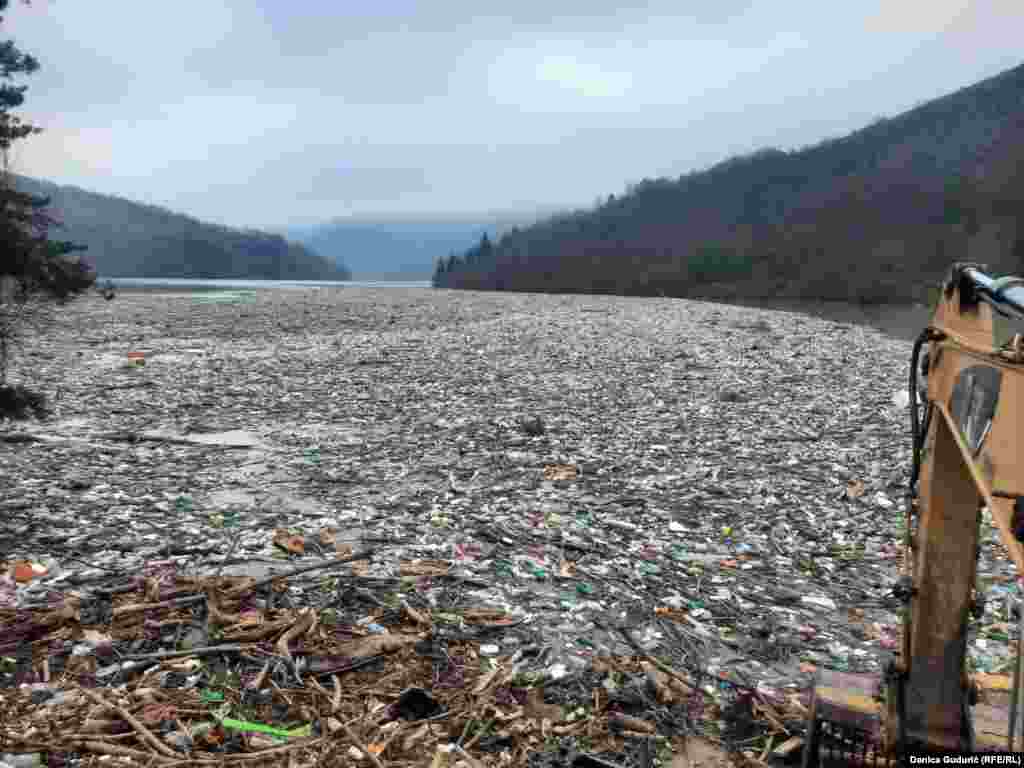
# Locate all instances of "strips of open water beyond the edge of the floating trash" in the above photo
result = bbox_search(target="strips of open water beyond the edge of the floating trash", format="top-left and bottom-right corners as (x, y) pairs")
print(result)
(97, 278), (930, 340)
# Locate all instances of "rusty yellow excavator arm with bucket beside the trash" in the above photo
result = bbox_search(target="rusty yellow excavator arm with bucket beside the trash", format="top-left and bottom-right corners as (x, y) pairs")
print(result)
(804, 263), (1024, 768)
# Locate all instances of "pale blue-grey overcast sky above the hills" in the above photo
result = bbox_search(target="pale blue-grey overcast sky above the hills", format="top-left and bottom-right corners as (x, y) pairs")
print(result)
(0, 0), (1024, 228)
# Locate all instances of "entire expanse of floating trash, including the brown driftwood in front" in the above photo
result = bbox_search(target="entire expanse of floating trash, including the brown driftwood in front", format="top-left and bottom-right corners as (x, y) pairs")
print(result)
(0, 287), (1020, 768)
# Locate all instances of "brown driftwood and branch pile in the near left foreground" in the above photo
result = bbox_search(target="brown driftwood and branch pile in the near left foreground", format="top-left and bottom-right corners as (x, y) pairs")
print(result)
(0, 551), (753, 766)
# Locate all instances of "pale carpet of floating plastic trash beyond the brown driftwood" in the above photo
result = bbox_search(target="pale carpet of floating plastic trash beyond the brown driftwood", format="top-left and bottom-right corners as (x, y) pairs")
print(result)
(0, 288), (983, 729)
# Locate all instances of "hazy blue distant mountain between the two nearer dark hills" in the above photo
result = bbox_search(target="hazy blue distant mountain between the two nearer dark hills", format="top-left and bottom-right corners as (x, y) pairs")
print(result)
(287, 214), (552, 281)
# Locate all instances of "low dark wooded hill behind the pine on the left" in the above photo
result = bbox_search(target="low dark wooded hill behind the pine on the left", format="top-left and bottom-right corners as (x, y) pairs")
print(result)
(14, 176), (350, 280)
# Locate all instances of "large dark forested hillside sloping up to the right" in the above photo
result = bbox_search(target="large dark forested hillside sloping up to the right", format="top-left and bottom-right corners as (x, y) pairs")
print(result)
(433, 66), (1024, 302)
